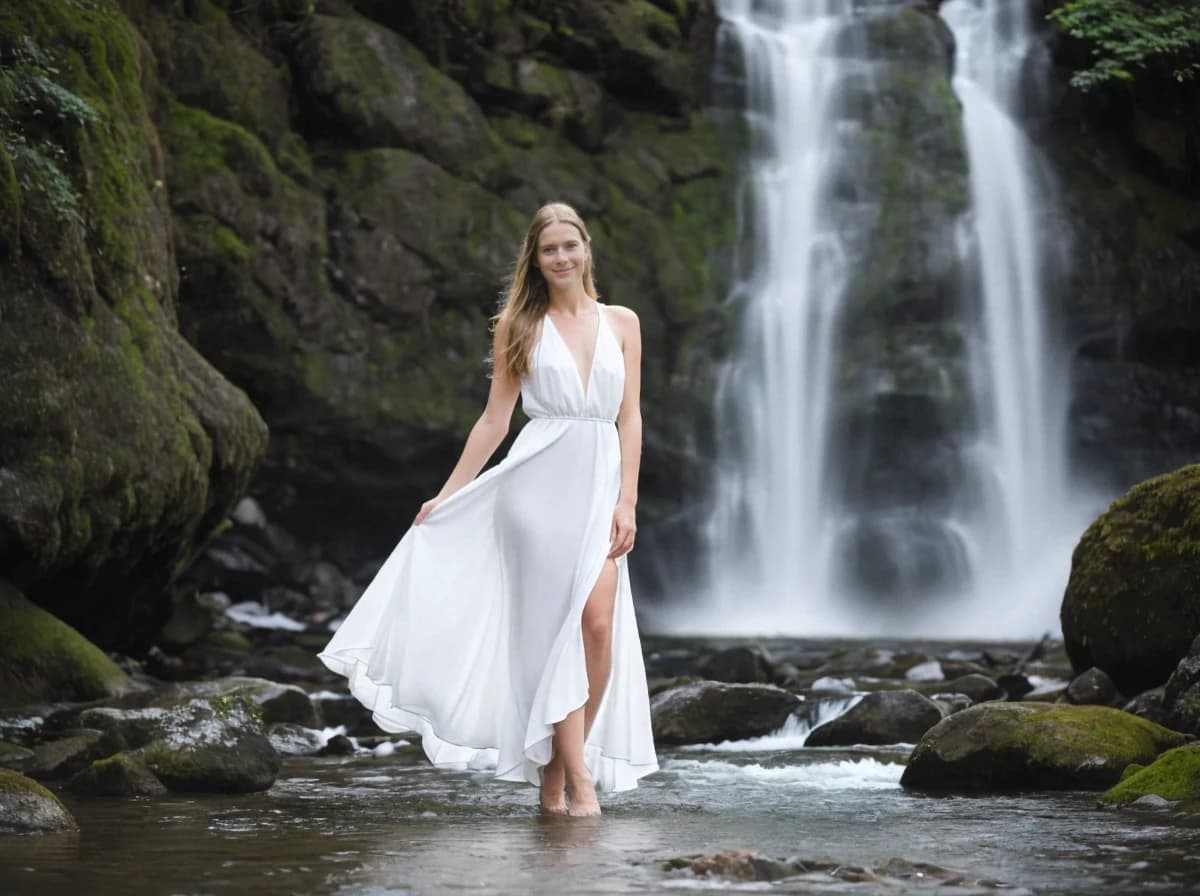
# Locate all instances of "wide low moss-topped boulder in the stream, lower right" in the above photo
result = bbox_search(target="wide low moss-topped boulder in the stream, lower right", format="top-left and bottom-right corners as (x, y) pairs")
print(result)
(900, 703), (1188, 792)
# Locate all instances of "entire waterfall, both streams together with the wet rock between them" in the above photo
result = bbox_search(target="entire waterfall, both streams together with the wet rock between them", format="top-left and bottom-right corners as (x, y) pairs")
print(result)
(654, 0), (1086, 636)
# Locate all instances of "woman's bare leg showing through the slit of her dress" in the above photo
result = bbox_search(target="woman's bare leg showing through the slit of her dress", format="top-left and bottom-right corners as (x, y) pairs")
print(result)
(554, 560), (617, 816)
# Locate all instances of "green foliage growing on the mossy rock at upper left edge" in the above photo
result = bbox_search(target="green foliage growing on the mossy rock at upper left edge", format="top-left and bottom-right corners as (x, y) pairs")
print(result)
(0, 37), (100, 223)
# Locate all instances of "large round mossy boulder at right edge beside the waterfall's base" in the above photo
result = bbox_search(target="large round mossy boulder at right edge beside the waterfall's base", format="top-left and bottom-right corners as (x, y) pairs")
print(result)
(1061, 464), (1200, 693)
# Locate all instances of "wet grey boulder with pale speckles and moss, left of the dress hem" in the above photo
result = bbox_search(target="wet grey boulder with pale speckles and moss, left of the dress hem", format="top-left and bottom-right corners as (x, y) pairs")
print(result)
(79, 696), (280, 793)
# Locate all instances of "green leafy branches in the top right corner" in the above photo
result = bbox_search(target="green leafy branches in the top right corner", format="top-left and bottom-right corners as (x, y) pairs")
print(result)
(1049, 0), (1200, 90)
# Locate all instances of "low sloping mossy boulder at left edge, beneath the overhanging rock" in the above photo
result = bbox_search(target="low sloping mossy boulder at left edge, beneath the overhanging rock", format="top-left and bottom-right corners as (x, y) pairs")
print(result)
(0, 579), (131, 706)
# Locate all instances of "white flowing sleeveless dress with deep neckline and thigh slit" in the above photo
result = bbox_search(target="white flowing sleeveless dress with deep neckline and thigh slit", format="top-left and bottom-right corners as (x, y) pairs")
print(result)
(319, 302), (658, 790)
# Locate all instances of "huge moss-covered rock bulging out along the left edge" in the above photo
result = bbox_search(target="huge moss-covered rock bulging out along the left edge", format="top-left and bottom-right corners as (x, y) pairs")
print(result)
(0, 0), (266, 648)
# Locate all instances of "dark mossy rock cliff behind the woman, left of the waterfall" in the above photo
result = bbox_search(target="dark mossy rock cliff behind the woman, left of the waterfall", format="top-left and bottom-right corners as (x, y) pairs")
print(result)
(114, 0), (736, 575)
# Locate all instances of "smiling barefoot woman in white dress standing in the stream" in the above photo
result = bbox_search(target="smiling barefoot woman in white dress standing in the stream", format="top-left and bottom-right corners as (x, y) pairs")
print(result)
(320, 203), (658, 816)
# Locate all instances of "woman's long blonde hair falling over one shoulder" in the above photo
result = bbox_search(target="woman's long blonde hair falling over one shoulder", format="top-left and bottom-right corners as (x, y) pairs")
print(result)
(492, 203), (600, 379)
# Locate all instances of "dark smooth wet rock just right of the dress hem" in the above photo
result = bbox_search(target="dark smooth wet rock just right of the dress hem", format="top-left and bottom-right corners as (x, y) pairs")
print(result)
(650, 681), (798, 745)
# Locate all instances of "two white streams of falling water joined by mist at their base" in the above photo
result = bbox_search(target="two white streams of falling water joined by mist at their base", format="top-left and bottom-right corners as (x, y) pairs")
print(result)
(652, 0), (1093, 637)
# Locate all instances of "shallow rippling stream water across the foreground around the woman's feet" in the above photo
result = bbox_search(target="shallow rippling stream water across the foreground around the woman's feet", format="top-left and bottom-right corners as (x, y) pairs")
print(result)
(0, 738), (1200, 896)
